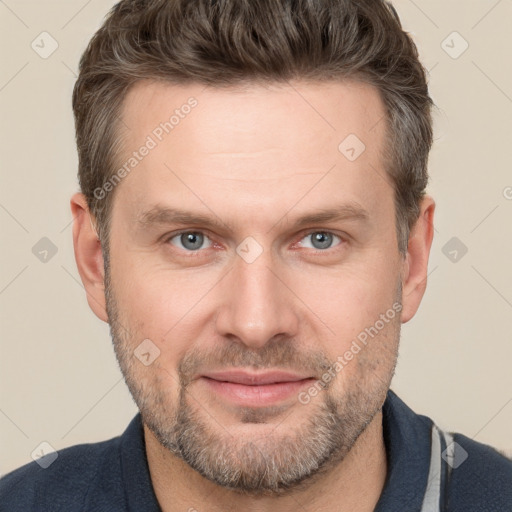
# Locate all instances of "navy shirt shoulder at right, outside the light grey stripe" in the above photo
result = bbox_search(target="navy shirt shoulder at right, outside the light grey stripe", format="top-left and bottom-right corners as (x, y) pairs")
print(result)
(447, 433), (512, 512)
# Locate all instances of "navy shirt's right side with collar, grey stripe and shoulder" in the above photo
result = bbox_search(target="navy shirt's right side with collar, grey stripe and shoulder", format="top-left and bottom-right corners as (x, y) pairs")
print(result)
(383, 390), (512, 512)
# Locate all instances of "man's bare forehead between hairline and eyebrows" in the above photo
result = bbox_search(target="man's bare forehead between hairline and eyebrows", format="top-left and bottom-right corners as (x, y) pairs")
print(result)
(111, 81), (392, 230)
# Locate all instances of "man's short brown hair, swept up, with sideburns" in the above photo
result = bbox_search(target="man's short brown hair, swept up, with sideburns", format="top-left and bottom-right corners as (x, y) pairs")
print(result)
(73, 0), (433, 258)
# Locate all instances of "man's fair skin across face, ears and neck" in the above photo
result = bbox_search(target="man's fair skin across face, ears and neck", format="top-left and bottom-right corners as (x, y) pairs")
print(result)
(71, 81), (435, 512)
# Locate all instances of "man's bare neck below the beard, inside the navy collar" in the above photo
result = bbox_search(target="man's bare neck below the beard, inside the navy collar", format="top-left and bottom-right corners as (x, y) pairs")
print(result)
(144, 412), (387, 512)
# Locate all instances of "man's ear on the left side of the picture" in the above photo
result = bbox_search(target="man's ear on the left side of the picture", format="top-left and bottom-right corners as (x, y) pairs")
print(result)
(70, 193), (108, 322)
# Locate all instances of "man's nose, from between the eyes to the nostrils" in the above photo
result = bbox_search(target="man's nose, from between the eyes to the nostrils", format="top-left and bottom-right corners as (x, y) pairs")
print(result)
(216, 247), (299, 349)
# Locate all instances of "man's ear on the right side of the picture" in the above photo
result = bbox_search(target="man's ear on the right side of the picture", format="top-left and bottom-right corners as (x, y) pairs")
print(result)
(401, 196), (436, 323)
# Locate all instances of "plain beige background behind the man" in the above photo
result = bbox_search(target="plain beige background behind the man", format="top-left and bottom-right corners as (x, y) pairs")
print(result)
(0, 0), (512, 474)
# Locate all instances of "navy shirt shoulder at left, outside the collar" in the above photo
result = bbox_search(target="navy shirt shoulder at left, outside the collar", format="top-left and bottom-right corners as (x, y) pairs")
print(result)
(0, 437), (125, 512)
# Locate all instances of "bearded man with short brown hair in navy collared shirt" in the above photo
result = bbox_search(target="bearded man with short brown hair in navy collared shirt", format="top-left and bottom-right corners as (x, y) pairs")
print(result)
(0, 0), (512, 512)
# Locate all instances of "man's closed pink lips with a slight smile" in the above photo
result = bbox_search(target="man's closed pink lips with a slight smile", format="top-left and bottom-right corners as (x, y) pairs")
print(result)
(199, 371), (316, 407)
